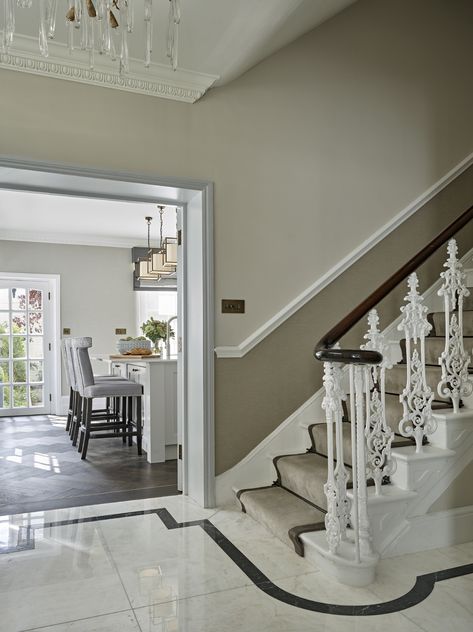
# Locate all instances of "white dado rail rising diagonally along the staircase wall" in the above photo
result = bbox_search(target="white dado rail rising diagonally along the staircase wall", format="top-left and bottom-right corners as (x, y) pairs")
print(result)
(215, 153), (473, 358)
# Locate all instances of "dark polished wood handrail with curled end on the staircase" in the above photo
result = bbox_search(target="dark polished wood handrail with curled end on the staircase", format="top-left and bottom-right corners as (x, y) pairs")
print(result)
(314, 206), (473, 364)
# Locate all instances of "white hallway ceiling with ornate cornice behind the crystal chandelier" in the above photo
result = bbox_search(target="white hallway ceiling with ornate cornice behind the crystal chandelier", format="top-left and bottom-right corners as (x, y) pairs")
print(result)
(0, 0), (356, 102)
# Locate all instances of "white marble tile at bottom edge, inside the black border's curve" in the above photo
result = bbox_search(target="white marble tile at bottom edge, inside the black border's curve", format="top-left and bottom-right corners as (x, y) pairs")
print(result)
(135, 587), (421, 632)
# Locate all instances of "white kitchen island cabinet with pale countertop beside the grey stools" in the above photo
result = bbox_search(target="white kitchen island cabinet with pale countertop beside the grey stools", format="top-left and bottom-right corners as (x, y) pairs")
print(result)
(92, 355), (177, 463)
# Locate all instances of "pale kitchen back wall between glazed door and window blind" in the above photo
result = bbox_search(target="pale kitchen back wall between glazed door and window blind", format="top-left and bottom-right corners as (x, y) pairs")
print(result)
(0, 241), (136, 393)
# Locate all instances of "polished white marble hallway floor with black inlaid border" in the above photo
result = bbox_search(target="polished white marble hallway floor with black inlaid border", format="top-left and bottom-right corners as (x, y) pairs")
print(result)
(0, 496), (473, 632)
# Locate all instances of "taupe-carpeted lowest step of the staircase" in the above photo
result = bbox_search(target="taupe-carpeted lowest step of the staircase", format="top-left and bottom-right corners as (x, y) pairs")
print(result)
(239, 486), (325, 548)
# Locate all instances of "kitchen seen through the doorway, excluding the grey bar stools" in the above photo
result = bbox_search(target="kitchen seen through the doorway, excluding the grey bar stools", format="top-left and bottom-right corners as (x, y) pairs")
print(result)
(0, 191), (182, 512)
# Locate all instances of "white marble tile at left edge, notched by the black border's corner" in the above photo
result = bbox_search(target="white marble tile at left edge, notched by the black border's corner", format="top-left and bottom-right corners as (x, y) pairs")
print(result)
(0, 523), (130, 632)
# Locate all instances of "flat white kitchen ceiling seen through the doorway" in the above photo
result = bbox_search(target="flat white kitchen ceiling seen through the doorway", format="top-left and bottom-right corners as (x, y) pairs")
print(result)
(0, 190), (176, 248)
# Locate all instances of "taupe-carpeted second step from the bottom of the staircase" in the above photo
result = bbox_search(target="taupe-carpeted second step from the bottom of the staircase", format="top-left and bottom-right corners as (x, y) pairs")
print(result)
(274, 452), (334, 511)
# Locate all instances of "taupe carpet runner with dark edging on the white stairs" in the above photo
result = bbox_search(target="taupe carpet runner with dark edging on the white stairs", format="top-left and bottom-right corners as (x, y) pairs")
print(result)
(237, 292), (473, 555)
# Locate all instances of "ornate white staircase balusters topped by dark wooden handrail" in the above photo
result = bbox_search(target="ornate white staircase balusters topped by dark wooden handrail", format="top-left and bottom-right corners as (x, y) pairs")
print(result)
(314, 202), (473, 579)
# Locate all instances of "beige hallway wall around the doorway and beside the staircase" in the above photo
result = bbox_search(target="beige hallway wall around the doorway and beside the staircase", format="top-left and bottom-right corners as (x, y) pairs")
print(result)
(0, 0), (473, 471)
